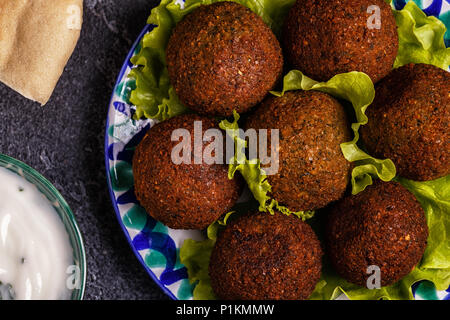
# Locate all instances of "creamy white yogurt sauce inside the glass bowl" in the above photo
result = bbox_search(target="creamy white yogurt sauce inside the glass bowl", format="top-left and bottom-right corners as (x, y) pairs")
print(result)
(0, 168), (73, 300)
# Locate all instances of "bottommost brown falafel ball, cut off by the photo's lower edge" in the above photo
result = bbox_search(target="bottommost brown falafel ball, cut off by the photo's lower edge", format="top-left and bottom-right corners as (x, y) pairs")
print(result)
(209, 212), (322, 300)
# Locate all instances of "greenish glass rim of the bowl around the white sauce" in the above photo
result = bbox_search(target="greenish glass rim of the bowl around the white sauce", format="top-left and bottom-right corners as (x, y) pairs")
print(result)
(0, 153), (87, 300)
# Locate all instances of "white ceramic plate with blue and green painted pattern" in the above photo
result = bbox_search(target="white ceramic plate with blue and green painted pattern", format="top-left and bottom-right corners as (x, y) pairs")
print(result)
(105, 0), (450, 300)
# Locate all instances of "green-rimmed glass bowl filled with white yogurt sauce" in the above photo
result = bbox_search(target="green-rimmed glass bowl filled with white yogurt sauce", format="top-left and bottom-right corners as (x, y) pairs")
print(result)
(0, 154), (86, 300)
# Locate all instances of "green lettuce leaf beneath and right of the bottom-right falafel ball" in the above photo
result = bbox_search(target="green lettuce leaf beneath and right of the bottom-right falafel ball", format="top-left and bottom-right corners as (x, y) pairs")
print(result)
(311, 175), (450, 300)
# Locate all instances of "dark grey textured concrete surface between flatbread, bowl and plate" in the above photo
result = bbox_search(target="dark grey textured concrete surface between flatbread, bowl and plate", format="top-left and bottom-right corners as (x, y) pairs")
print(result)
(0, 0), (168, 299)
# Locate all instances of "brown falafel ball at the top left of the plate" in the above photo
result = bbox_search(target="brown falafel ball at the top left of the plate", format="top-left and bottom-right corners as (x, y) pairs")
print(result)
(166, 2), (283, 116)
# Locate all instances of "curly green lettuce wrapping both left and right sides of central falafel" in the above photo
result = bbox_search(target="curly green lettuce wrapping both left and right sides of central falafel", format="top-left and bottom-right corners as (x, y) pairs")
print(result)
(215, 70), (396, 215)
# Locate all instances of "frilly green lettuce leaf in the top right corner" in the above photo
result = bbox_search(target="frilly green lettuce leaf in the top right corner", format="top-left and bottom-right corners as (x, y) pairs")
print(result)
(393, 1), (450, 70)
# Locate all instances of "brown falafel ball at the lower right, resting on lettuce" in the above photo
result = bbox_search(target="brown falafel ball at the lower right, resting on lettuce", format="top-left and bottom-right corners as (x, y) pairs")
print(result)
(326, 181), (428, 287)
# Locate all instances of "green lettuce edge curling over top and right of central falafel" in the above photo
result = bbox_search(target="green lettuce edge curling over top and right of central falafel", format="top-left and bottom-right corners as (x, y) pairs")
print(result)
(272, 70), (396, 194)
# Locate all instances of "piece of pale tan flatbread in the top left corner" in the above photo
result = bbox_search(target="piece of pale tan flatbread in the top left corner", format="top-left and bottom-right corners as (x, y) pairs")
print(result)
(0, 0), (83, 105)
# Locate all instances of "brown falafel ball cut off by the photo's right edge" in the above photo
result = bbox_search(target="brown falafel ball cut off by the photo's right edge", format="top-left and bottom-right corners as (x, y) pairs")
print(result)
(361, 64), (450, 181)
